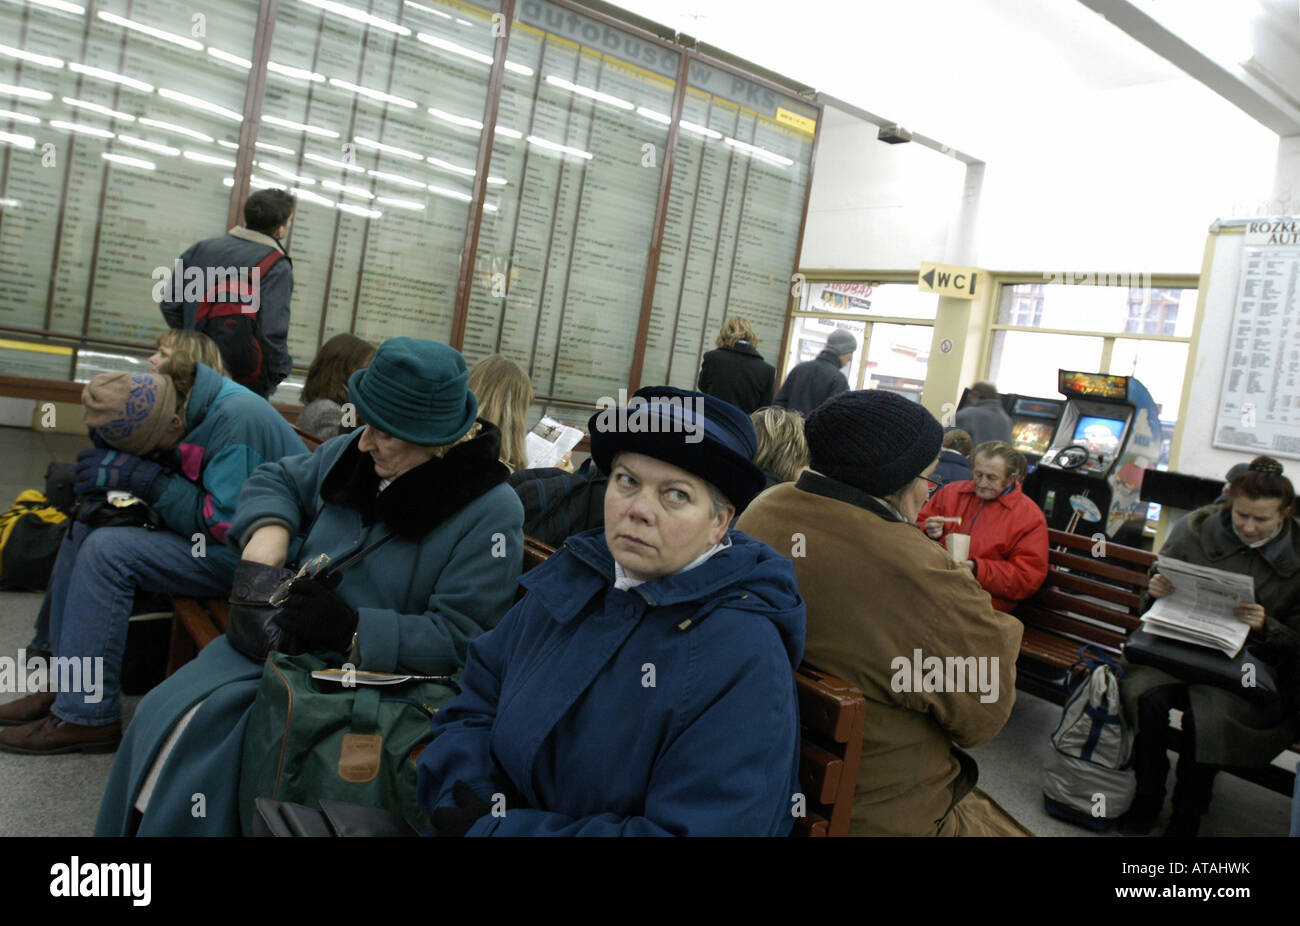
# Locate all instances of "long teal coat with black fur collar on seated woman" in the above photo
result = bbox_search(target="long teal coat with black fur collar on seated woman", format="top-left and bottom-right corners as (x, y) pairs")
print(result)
(95, 427), (524, 836)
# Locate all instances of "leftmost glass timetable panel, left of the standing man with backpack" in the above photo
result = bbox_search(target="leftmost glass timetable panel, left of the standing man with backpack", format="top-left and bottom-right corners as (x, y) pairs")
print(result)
(0, 0), (257, 345)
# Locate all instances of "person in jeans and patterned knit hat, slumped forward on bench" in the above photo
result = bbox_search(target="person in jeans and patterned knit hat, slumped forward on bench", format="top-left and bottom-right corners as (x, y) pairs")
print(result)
(0, 358), (306, 756)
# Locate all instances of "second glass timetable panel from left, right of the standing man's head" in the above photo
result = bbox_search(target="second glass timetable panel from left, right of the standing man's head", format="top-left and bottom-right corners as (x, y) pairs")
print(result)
(252, 0), (501, 365)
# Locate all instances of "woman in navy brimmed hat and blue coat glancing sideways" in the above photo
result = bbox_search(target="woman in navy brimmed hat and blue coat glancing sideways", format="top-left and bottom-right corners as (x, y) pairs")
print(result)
(419, 388), (803, 836)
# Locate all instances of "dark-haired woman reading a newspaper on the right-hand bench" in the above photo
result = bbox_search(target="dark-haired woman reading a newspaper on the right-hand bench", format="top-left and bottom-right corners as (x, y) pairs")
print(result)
(1121, 456), (1300, 836)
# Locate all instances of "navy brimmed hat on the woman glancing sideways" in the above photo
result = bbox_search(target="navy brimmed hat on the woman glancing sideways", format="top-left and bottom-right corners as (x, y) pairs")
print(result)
(586, 386), (766, 512)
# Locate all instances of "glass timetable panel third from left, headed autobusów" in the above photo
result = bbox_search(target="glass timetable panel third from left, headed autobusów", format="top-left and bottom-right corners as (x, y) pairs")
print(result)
(463, 0), (679, 402)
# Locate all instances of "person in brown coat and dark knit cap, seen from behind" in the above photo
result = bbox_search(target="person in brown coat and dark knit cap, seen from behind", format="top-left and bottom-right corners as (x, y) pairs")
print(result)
(736, 390), (1031, 836)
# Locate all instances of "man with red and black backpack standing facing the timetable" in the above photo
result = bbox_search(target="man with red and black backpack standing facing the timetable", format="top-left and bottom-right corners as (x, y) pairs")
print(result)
(153, 190), (294, 397)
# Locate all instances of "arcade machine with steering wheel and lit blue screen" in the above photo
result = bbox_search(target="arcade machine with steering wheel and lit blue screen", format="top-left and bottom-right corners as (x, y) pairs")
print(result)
(1024, 369), (1161, 546)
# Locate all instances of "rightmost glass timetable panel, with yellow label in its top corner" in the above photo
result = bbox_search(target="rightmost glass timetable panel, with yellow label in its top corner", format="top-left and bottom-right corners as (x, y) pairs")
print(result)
(641, 61), (816, 388)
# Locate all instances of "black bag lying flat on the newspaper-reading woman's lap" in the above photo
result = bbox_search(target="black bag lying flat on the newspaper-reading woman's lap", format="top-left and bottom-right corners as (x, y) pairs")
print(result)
(1125, 628), (1282, 709)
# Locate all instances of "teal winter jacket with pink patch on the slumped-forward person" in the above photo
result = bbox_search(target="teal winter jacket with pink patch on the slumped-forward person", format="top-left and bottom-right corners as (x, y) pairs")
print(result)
(153, 363), (307, 570)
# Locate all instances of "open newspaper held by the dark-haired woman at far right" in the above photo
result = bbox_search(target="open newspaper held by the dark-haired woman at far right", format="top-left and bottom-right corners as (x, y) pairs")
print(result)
(1141, 557), (1255, 659)
